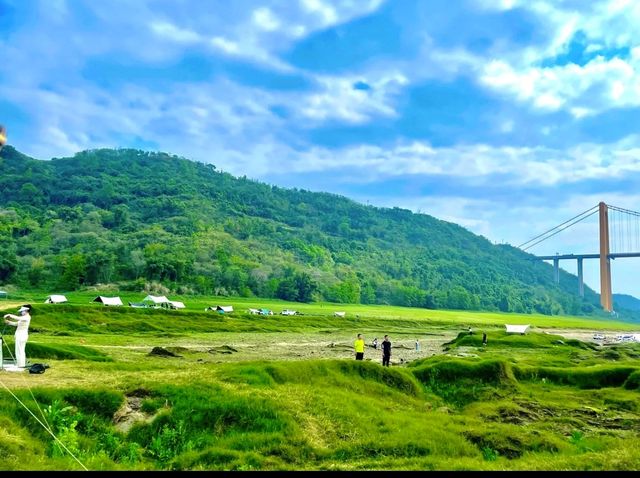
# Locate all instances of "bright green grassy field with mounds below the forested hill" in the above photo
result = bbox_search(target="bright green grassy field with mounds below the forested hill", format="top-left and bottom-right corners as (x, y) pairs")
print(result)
(0, 292), (640, 471)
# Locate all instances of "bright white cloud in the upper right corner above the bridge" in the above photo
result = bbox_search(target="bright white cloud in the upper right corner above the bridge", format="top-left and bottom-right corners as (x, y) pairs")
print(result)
(475, 0), (640, 114)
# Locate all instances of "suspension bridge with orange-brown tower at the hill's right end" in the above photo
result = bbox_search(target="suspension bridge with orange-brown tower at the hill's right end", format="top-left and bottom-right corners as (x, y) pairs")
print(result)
(518, 202), (640, 312)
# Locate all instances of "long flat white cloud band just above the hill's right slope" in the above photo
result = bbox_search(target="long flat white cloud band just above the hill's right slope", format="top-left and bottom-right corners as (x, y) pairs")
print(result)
(258, 137), (640, 187)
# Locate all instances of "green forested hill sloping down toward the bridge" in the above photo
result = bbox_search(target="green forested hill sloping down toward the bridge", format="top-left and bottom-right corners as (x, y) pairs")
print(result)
(0, 147), (598, 314)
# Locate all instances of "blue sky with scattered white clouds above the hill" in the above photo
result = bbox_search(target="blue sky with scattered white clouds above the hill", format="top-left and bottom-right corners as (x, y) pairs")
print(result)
(0, 0), (640, 296)
